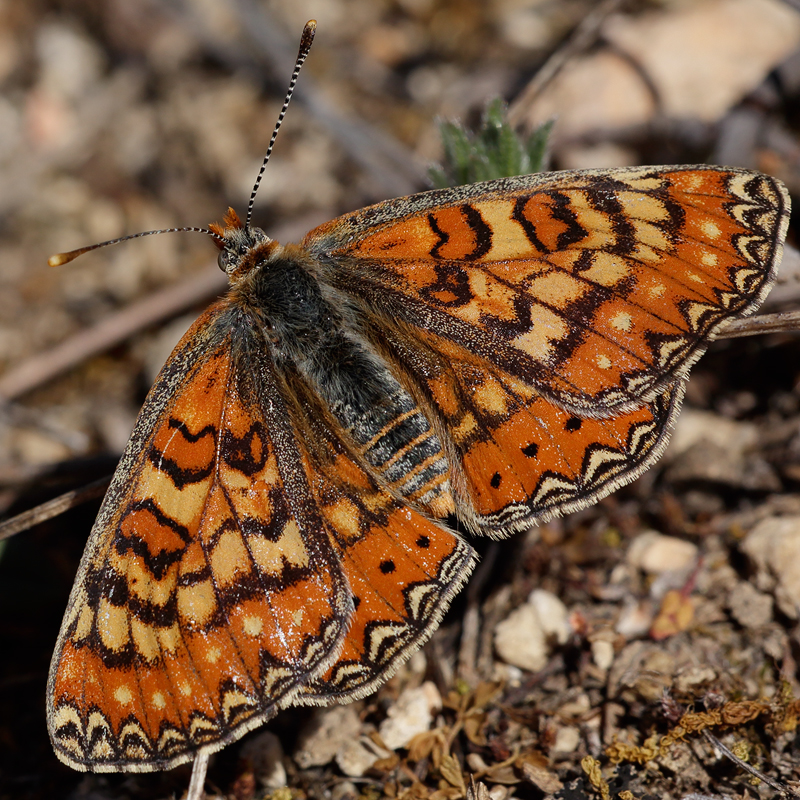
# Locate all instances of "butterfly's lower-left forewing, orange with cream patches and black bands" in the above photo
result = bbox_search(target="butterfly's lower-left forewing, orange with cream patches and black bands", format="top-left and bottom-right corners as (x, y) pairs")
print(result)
(48, 303), (353, 771)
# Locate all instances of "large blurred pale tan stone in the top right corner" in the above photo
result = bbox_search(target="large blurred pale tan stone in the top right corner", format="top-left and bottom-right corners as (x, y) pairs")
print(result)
(528, 0), (800, 140)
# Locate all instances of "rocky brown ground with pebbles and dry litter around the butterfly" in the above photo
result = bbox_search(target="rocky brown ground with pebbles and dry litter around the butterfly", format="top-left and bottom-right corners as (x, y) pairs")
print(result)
(0, 0), (800, 800)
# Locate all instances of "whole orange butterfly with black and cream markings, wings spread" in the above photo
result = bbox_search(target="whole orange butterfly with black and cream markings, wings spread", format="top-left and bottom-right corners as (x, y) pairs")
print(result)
(47, 20), (789, 772)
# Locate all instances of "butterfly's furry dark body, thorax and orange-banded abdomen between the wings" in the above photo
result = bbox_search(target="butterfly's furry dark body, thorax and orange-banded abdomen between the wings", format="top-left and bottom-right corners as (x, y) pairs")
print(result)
(233, 242), (450, 516)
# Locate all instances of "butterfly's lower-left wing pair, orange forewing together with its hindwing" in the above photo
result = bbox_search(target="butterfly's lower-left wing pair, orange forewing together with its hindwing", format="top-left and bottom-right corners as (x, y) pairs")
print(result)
(48, 301), (473, 771)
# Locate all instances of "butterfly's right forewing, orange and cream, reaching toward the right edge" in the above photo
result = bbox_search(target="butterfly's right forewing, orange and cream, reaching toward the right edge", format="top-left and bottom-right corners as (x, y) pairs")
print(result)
(304, 167), (789, 416)
